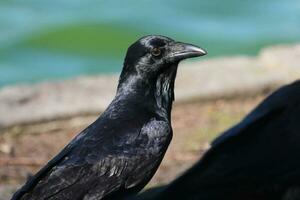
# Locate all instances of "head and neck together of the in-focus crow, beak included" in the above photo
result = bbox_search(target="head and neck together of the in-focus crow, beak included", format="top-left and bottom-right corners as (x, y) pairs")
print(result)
(118, 35), (206, 112)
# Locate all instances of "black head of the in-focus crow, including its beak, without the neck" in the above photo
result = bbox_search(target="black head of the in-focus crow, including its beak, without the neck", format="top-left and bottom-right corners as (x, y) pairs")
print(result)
(124, 35), (206, 78)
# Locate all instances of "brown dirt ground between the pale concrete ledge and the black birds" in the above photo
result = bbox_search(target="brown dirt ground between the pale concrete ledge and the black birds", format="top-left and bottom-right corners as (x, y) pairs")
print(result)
(0, 95), (265, 200)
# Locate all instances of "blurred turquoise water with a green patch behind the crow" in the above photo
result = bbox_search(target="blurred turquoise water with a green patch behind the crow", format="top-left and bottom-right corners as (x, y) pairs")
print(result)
(0, 0), (300, 87)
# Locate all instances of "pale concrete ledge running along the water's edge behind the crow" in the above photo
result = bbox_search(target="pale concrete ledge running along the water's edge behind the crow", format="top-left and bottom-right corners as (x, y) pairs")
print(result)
(0, 44), (300, 130)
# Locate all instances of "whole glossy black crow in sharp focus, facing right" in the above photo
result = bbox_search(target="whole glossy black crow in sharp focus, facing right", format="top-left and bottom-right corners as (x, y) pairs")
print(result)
(12, 36), (206, 200)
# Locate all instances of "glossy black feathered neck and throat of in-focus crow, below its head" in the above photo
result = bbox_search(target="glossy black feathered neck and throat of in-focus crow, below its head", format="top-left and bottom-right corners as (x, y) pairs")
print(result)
(116, 65), (177, 119)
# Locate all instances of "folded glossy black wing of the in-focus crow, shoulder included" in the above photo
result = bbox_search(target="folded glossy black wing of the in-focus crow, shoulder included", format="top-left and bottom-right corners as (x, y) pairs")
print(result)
(13, 120), (170, 200)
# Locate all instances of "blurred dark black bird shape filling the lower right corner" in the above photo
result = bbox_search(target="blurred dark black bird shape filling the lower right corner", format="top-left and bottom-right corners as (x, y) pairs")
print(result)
(132, 81), (300, 200)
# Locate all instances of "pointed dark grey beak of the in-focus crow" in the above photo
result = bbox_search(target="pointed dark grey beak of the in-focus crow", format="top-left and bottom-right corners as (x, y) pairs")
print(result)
(170, 42), (207, 61)
